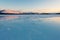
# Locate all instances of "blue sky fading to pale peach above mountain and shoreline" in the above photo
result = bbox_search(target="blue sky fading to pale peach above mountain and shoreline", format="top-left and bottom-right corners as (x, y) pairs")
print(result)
(0, 0), (60, 12)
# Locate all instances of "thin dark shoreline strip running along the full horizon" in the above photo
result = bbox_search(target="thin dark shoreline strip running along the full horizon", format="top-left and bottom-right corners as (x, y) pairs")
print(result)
(0, 13), (60, 15)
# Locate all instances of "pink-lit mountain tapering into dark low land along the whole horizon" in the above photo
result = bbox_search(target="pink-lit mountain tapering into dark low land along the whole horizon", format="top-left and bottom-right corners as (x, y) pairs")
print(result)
(0, 9), (60, 15)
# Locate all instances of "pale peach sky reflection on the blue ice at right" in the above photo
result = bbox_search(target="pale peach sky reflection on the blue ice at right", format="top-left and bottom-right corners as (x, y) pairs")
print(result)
(33, 17), (60, 22)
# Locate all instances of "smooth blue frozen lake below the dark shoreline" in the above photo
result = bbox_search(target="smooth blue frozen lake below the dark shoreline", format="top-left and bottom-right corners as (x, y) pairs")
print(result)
(0, 15), (60, 40)
